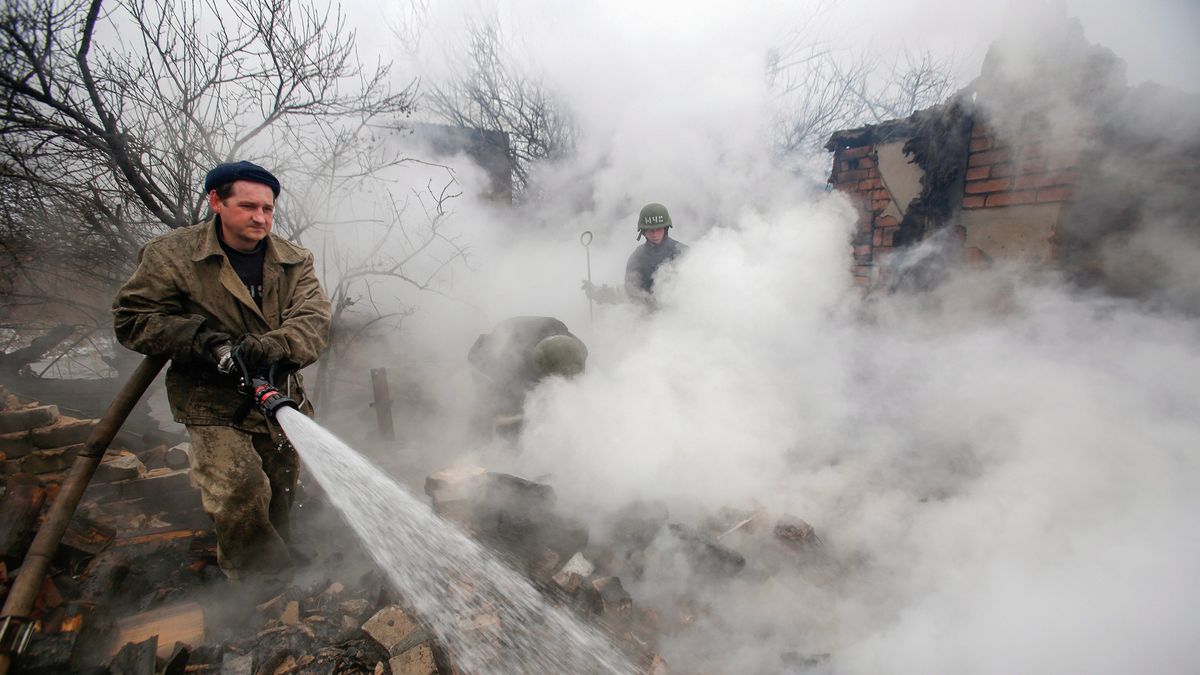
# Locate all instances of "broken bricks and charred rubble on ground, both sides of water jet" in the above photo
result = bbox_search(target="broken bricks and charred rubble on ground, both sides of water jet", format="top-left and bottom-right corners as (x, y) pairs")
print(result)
(0, 381), (821, 675)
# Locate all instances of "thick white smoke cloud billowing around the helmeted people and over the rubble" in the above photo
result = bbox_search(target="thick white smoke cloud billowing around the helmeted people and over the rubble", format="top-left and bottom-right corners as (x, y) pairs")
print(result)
(316, 2), (1200, 673)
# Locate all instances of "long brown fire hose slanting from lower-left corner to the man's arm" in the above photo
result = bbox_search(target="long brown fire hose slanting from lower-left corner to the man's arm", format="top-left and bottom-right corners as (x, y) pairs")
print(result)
(0, 357), (167, 675)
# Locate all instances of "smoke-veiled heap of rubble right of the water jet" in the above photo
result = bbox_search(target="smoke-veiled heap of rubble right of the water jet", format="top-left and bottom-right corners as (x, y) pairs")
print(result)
(425, 466), (838, 674)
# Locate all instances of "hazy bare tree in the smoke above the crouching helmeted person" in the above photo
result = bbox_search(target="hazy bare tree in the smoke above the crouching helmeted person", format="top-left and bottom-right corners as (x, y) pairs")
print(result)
(425, 18), (577, 199)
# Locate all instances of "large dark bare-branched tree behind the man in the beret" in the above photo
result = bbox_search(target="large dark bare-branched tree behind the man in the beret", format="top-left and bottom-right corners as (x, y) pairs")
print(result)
(0, 0), (414, 324)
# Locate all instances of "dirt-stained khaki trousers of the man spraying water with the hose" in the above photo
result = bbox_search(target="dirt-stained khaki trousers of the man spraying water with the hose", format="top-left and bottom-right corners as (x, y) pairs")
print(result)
(187, 424), (300, 580)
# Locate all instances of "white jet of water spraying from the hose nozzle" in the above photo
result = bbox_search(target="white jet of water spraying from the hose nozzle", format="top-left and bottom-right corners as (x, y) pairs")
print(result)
(272, 401), (637, 675)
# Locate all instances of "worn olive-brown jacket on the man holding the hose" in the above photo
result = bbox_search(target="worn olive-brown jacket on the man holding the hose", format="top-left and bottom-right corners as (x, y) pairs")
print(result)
(113, 220), (330, 431)
